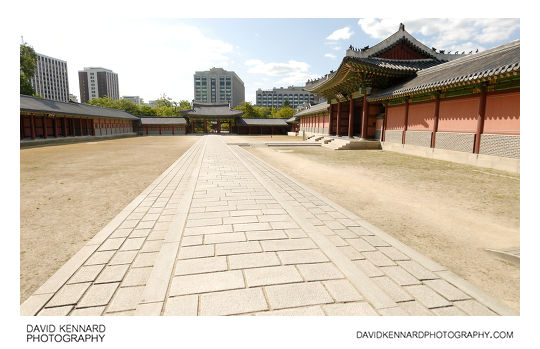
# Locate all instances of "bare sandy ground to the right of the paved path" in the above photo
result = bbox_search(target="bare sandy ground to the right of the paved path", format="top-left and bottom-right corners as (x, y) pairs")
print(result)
(237, 137), (520, 311)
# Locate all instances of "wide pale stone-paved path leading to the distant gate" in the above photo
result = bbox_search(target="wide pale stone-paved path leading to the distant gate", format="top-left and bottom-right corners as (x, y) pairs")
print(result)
(21, 136), (516, 315)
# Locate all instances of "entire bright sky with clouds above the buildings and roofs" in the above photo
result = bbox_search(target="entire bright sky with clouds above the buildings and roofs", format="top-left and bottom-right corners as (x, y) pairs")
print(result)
(20, 16), (520, 103)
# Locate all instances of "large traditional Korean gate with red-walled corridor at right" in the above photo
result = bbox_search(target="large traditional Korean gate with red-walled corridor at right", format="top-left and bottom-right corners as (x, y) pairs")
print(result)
(295, 25), (520, 171)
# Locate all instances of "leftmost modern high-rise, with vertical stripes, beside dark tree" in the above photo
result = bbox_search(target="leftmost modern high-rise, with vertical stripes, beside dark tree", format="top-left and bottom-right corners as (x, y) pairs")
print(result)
(30, 53), (69, 102)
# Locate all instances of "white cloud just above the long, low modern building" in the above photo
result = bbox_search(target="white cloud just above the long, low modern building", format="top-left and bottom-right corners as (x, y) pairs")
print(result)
(245, 59), (317, 86)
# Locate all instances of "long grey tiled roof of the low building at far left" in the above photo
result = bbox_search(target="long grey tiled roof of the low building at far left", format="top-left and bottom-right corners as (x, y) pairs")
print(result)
(20, 95), (139, 120)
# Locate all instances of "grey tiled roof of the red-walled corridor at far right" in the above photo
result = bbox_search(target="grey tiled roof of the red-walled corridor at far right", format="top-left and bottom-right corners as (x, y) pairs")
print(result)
(368, 40), (520, 101)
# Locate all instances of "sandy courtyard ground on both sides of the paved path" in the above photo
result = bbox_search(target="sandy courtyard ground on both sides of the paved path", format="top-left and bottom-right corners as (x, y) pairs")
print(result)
(20, 136), (520, 310)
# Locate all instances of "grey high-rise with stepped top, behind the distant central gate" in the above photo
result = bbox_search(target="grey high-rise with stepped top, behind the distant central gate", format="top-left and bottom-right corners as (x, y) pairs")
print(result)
(193, 68), (246, 108)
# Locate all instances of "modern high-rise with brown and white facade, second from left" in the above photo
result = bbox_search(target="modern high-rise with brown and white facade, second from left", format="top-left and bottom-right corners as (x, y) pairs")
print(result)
(79, 67), (120, 103)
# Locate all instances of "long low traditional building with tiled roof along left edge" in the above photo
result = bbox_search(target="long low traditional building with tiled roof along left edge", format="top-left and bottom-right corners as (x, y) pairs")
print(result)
(20, 95), (139, 142)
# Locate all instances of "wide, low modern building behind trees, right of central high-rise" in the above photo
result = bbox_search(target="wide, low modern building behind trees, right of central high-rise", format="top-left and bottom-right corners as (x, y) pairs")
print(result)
(255, 86), (325, 109)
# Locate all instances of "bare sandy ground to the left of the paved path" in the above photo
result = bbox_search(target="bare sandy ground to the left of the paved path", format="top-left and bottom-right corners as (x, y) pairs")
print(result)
(20, 136), (199, 303)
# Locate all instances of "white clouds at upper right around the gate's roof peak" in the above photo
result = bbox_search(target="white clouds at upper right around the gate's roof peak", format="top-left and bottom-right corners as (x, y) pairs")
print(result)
(358, 18), (520, 50)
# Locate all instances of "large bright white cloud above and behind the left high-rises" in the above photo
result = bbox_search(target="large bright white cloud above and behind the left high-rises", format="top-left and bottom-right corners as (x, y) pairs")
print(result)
(20, 19), (234, 101)
